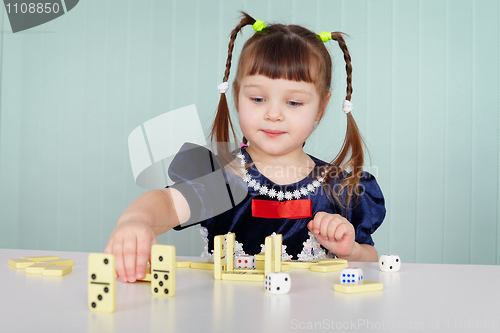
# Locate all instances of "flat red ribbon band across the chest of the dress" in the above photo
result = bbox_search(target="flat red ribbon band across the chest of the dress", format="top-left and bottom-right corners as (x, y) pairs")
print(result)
(252, 199), (312, 219)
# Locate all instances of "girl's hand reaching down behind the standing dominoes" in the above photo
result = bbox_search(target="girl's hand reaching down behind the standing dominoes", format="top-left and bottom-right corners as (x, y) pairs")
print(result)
(104, 221), (158, 282)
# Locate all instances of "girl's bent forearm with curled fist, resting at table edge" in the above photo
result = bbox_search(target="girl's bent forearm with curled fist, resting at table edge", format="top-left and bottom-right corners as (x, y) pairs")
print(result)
(307, 212), (378, 261)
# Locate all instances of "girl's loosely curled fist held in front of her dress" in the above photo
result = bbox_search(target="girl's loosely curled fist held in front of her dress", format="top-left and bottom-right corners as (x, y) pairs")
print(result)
(307, 212), (356, 257)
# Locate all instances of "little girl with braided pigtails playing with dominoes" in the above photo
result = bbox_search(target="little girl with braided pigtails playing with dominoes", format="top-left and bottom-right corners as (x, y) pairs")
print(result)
(105, 13), (385, 282)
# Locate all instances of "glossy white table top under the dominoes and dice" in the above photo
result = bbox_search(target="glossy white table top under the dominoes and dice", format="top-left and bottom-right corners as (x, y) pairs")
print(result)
(0, 249), (500, 333)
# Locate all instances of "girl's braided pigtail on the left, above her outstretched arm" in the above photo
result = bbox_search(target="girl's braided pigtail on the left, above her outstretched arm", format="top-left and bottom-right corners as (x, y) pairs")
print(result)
(210, 12), (255, 165)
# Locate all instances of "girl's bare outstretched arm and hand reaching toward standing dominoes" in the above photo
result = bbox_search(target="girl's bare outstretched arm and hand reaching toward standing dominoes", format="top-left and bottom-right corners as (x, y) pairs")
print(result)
(104, 188), (190, 282)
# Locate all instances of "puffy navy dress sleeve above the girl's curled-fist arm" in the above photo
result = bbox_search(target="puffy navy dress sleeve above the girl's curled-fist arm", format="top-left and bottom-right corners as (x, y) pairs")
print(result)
(343, 172), (386, 246)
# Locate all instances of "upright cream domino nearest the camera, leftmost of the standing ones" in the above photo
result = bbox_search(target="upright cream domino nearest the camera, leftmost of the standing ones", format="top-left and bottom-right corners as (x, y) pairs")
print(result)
(88, 253), (116, 312)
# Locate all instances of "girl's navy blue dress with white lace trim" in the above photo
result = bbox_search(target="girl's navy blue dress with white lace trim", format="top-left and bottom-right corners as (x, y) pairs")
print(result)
(168, 143), (386, 259)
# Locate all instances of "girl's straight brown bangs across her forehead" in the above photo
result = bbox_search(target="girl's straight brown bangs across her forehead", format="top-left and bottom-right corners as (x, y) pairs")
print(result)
(240, 35), (321, 83)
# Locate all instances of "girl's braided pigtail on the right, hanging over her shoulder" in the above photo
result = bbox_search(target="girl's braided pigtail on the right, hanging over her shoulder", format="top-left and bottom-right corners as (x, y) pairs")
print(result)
(325, 32), (365, 209)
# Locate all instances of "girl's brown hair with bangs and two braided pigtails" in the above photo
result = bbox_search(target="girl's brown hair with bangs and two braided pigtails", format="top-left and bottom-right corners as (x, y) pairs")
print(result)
(211, 12), (364, 208)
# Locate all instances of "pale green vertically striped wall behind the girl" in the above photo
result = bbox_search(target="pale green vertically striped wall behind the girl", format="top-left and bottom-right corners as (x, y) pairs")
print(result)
(0, 0), (500, 264)
